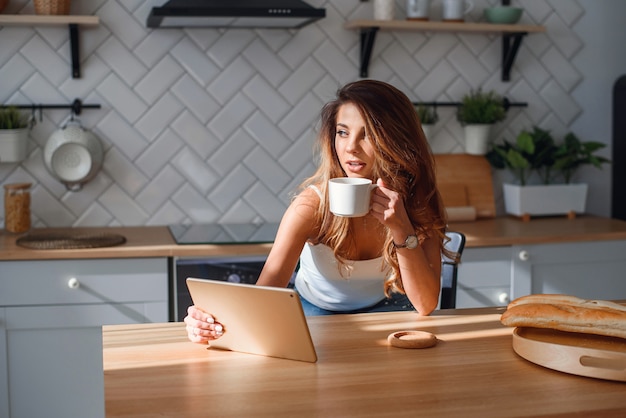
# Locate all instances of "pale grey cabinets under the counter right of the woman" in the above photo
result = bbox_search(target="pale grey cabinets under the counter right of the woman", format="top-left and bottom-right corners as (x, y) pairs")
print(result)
(456, 240), (626, 308)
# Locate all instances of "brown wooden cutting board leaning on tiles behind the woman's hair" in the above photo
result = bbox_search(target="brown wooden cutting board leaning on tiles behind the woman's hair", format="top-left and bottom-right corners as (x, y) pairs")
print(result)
(434, 154), (496, 218)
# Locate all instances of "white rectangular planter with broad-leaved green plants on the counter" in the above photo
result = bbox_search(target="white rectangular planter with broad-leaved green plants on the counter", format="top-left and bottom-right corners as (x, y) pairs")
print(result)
(486, 127), (609, 219)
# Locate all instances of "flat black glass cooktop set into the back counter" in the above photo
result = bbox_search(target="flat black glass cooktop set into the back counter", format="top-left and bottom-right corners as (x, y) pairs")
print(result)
(169, 223), (278, 244)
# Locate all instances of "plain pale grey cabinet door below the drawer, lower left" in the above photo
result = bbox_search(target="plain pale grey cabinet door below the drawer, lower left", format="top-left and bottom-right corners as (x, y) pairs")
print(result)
(0, 305), (105, 418)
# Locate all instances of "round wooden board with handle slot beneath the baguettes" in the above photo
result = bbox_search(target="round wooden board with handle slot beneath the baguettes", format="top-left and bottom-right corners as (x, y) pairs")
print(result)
(513, 327), (626, 382)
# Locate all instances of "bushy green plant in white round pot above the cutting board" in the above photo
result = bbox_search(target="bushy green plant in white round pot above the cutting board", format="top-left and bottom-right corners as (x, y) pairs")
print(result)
(457, 89), (506, 155)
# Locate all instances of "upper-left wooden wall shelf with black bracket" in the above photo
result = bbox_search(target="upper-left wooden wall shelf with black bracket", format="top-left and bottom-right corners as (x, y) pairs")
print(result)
(0, 14), (100, 78)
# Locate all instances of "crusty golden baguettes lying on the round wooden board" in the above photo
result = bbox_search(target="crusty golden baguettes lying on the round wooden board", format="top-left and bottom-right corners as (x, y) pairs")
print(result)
(500, 294), (626, 338)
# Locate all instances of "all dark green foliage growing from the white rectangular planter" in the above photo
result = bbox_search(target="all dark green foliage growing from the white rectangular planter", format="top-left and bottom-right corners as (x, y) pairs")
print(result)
(485, 126), (609, 186)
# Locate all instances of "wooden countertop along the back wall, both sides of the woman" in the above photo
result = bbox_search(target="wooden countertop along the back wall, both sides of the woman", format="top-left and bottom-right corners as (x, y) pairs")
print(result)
(0, 216), (626, 260)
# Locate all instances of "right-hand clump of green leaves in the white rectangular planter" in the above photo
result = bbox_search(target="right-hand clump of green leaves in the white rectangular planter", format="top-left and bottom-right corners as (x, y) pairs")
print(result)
(554, 132), (611, 183)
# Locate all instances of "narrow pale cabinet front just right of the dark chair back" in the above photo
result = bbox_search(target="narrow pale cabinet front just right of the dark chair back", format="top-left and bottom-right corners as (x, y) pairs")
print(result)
(456, 247), (511, 308)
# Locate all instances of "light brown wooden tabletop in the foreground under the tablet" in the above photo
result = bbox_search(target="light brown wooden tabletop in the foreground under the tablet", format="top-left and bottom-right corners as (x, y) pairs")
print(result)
(104, 309), (626, 417)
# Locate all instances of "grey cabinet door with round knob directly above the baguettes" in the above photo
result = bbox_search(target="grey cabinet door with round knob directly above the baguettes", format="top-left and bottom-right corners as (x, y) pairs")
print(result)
(513, 240), (626, 299)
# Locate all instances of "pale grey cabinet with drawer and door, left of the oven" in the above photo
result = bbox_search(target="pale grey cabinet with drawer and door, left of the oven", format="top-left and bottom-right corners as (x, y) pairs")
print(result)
(0, 258), (168, 418)
